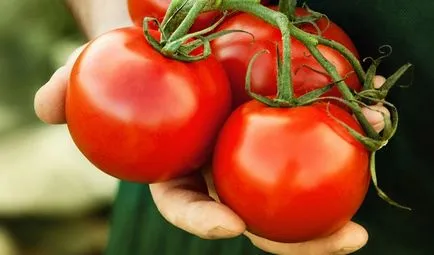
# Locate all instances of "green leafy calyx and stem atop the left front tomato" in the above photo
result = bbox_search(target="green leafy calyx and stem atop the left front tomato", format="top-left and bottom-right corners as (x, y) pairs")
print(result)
(143, 0), (265, 62)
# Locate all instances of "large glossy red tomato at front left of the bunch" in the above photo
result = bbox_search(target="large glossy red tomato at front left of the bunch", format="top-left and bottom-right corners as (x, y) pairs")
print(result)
(66, 27), (231, 182)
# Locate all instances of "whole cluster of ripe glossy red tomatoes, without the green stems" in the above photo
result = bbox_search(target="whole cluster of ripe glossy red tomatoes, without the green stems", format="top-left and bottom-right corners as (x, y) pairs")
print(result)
(66, 0), (370, 242)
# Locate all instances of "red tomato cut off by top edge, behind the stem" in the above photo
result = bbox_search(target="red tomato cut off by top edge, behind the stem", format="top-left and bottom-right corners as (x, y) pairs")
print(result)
(128, 0), (269, 31)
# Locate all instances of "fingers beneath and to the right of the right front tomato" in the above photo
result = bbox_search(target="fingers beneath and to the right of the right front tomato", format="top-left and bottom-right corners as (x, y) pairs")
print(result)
(151, 76), (390, 255)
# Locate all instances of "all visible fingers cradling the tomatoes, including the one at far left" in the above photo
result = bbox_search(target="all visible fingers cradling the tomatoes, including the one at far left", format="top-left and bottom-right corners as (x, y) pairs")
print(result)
(35, 39), (388, 255)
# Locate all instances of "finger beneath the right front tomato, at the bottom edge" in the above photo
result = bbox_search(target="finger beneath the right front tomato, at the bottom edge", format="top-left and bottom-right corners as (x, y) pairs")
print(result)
(245, 222), (368, 255)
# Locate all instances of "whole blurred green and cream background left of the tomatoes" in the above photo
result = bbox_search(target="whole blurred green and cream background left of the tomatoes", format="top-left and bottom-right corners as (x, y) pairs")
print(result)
(0, 0), (116, 255)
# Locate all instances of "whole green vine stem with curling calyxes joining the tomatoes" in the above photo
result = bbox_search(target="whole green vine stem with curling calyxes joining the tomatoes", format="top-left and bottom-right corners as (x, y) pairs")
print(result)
(140, 0), (411, 213)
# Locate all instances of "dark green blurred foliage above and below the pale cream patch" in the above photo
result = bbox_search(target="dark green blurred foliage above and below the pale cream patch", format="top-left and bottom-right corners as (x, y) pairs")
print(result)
(0, 0), (96, 255)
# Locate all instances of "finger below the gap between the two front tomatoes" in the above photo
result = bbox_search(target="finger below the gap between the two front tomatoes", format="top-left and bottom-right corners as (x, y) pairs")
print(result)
(150, 175), (245, 239)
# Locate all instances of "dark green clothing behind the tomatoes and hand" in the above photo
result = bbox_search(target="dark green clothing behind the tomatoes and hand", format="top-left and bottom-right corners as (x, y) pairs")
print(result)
(107, 0), (434, 255)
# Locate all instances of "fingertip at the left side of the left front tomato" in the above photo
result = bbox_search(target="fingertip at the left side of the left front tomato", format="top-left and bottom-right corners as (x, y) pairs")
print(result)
(34, 46), (84, 124)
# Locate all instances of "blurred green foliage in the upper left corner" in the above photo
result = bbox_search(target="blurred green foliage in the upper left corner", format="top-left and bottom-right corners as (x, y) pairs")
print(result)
(0, 0), (83, 129)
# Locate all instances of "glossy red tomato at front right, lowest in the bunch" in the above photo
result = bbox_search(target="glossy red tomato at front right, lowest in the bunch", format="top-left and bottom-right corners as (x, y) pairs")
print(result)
(213, 101), (370, 242)
